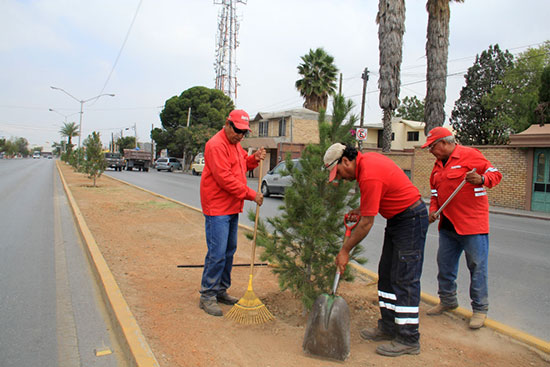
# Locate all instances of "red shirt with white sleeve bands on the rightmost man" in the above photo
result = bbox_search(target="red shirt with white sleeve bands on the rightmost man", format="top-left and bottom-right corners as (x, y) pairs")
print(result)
(430, 144), (502, 235)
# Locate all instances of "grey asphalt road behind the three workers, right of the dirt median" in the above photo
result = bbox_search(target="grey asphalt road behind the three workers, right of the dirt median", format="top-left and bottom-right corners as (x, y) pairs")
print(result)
(106, 170), (550, 341)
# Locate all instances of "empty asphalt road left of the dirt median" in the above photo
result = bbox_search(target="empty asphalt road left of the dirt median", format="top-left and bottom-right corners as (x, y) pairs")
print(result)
(0, 159), (123, 367)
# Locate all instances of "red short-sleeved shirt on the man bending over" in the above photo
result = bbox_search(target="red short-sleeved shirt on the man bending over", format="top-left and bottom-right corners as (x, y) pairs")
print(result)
(355, 152), (420, 219)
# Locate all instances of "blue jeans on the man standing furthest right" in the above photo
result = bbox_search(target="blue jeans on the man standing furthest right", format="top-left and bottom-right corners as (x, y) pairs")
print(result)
(437, 229), (489, 313)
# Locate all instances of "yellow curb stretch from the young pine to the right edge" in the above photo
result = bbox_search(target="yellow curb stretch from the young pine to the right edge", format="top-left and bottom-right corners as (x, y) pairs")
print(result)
(349, 263), (550, 353)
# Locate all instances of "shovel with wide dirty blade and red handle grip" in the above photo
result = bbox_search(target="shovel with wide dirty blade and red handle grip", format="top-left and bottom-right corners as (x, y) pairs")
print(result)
(302, 215), (358, 361)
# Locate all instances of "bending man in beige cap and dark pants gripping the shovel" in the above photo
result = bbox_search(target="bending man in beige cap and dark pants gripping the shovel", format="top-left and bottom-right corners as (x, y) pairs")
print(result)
(324, 143), (428, 357)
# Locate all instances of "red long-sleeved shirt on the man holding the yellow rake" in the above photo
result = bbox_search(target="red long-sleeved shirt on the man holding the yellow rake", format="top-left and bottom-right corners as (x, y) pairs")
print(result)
(200, 129), (258, 215)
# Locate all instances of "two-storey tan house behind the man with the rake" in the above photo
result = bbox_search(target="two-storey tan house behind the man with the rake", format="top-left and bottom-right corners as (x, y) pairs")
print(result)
(241, 108), (322, 173)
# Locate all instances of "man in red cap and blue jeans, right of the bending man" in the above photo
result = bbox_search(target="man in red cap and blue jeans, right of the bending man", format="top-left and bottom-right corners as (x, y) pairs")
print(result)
(422, 127), (502, 329)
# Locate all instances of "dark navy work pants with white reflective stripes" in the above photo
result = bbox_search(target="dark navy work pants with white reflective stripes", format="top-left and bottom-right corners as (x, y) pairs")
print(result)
(378, 203), (429, 345)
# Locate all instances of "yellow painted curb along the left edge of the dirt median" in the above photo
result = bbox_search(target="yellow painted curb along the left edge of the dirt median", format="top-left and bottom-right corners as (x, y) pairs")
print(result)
(56, 161), (159, 367)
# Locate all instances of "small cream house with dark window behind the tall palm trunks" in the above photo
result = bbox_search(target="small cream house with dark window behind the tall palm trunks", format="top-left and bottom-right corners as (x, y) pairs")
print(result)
(362, 117), (432, 151)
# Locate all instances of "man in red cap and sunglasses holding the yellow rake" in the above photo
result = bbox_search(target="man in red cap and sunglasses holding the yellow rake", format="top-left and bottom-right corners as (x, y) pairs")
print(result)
(199, 110), (265, 316)
